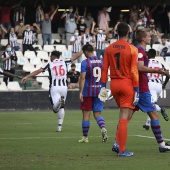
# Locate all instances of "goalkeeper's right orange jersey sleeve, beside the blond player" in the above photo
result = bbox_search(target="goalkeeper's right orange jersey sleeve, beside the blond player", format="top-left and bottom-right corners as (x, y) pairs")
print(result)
(130, 46), (139, 87)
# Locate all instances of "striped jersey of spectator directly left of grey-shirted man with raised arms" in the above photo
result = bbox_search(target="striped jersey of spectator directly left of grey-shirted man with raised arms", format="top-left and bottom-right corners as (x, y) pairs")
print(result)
(22, 30), (34, 45)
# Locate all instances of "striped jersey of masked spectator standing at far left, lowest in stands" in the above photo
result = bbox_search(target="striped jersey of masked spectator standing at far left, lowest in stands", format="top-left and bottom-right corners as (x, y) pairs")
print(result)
(2, 51), (17, 70)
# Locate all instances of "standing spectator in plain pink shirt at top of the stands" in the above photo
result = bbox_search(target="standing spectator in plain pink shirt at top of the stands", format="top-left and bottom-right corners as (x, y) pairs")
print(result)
(98, 7), (110, 30)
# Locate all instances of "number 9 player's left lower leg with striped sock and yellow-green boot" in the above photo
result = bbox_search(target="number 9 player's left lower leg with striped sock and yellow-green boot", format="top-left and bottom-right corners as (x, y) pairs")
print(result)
(78, 110), (91, 143)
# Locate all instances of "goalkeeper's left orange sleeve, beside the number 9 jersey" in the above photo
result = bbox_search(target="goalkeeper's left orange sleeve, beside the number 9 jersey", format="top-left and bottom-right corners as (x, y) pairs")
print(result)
(101, 48), (110, 83)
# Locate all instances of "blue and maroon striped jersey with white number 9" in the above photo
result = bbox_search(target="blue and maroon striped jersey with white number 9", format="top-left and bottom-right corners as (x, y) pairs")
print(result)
(81, 56), (103, 97)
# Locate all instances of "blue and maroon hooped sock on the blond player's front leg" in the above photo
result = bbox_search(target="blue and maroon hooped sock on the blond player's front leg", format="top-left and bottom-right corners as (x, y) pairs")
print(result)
(151, 120), (163, 144)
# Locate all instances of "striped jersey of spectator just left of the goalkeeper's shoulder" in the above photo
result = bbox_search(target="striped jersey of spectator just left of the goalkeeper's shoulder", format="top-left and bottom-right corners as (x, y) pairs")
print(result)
(96, 33), (106, 50)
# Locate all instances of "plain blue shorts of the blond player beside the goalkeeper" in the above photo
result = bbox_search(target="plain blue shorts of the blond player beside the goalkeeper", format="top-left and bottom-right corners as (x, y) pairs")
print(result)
(137, 92), (156, 113)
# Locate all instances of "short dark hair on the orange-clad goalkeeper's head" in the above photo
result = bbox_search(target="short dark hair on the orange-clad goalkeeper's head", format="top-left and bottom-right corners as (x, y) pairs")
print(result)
(117, 22), (129, 37)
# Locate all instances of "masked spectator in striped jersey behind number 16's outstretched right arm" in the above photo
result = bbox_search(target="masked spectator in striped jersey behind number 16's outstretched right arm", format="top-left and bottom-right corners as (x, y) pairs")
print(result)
(70, 30), (82, 63)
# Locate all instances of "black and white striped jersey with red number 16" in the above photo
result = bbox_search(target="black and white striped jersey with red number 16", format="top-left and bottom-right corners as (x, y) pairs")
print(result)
(41, 59), (71, 87)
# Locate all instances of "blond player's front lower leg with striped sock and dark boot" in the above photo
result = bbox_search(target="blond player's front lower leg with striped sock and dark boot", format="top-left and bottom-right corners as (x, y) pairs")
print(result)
(148, 111), (170, 152)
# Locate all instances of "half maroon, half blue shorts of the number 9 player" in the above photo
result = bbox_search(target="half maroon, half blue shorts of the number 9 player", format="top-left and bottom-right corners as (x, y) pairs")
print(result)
(80, 97), (103, 112)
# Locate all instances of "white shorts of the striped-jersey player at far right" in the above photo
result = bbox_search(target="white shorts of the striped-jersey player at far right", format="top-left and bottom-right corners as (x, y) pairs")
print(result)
(148, 82), (162, 103)
